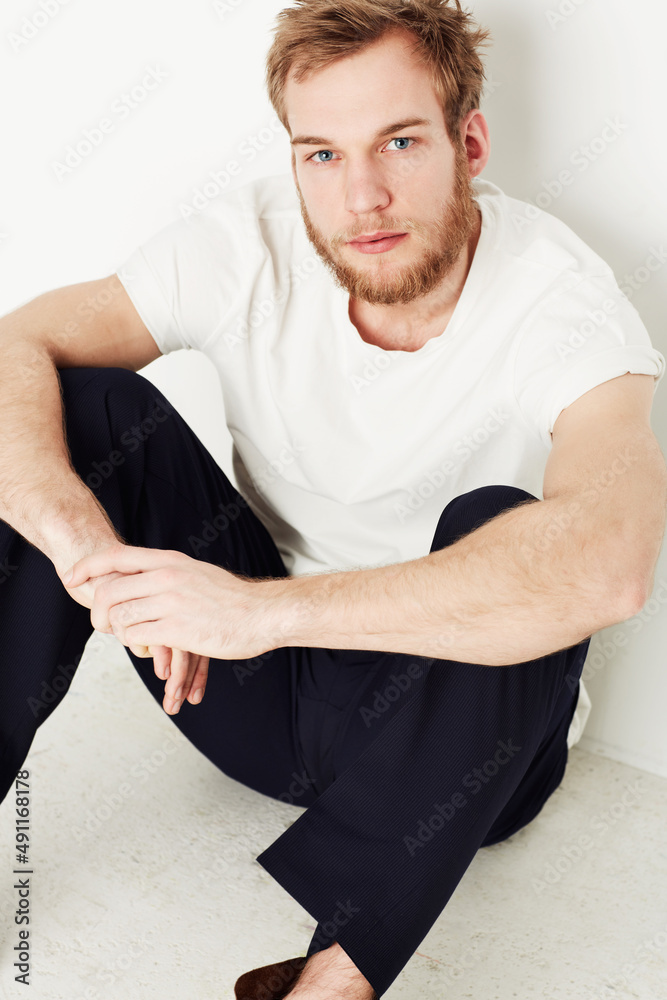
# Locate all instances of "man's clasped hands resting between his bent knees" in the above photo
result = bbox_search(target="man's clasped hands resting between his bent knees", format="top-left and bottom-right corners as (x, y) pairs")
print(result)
(59, 542), (289, 715)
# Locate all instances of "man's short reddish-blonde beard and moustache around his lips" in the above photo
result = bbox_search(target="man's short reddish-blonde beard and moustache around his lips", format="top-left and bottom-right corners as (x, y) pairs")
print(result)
(297, 144), (479, 306)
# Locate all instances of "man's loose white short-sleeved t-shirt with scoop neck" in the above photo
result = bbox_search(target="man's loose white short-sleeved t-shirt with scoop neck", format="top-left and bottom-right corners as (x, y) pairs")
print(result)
(117, 173), (665, 745)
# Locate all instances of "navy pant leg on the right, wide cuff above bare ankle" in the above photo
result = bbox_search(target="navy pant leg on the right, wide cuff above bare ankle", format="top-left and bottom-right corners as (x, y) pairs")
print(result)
(257, 486), (590, 996)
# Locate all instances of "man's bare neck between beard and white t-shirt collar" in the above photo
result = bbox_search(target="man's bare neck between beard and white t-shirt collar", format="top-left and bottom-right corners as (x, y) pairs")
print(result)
(348, 203), (482, 351)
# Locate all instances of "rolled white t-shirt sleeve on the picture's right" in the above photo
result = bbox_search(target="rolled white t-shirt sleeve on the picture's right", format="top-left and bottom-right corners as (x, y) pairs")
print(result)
(514, 272), (665, 447)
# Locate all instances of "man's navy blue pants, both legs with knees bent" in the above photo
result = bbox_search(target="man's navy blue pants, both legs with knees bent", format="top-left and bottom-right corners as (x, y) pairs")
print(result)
(0, 368), (590, 996)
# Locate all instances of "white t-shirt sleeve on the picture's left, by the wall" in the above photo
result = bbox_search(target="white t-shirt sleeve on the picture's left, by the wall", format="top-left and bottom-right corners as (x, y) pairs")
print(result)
(116, 196), (253, 354)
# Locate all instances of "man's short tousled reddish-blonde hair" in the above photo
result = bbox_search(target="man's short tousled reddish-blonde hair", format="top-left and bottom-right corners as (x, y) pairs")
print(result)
(266, 0), (490, 144)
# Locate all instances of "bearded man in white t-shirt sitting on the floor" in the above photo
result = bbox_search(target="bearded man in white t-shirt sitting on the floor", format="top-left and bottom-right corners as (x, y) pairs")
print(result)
(0, 0), (667, 1000)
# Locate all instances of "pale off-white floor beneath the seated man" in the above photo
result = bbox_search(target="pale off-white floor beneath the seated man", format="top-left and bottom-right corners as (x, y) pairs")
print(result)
(0, 633), (667, 1000)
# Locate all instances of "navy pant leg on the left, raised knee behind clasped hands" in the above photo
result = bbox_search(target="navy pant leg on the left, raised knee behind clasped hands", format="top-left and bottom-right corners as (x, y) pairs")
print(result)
(0, 368), (307, 804)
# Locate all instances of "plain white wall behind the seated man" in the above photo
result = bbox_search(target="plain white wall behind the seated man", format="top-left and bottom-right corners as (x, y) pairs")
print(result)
(0, 0), (667, 775)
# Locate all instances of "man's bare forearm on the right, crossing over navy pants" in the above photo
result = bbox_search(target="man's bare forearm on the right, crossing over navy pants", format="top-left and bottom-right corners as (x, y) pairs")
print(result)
(260, 498), (636, 666)
